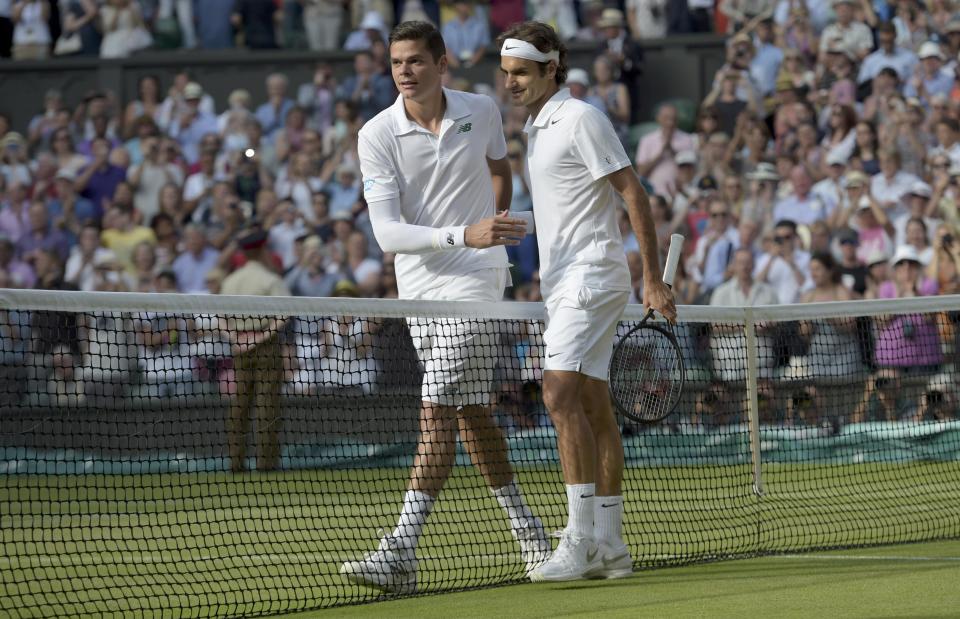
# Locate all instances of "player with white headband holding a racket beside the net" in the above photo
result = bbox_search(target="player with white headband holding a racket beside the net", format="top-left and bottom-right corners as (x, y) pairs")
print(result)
(500, 22), (676, 581)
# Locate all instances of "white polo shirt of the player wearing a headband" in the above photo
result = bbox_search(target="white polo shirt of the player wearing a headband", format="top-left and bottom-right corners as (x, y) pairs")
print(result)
(523, 88), (630, 298)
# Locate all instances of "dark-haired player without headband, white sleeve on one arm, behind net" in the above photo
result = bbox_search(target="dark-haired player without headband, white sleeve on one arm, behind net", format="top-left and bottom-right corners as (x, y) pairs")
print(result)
(340, 22), (552, 593)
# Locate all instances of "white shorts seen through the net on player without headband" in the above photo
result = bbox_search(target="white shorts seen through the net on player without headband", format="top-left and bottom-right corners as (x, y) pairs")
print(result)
(407, 269), (510, 408)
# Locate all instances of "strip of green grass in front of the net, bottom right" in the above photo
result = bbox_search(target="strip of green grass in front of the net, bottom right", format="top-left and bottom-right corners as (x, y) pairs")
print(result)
(302, 541), (960, 619)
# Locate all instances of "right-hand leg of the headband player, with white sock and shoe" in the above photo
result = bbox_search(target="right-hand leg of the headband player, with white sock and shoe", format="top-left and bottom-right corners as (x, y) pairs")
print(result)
(582, 377), (633, 578)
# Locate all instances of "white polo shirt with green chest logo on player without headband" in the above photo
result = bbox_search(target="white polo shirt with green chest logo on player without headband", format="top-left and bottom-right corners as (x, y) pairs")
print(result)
(359, 88), (508, 299)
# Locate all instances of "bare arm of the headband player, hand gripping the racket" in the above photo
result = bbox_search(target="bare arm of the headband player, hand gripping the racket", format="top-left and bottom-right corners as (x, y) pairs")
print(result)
(607, 166), (677, 322)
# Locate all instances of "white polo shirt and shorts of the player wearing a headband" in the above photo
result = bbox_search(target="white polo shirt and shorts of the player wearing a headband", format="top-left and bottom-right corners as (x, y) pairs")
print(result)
(524, 88), (630, 380)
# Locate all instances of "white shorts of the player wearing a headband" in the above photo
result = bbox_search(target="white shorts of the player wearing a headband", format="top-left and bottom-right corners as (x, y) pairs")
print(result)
(543, 286), (630, 381)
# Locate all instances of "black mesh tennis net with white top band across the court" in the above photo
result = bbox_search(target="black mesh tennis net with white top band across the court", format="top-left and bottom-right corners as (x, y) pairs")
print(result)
(0, 290), (960, 617)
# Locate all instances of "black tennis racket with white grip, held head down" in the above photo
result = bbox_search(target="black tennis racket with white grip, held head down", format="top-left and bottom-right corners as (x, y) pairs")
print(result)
(607, 234), (685, 424)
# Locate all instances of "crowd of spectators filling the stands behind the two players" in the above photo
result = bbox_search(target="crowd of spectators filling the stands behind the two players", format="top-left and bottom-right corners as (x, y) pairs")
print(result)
(0, 0), (960, 426)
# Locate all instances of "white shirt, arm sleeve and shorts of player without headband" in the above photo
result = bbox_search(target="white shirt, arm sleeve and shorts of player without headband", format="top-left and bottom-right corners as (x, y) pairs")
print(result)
(359, 88), (508, 407)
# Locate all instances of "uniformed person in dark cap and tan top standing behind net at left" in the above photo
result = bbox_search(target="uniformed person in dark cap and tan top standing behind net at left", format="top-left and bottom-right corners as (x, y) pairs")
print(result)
(220, 229), (290, 473)
